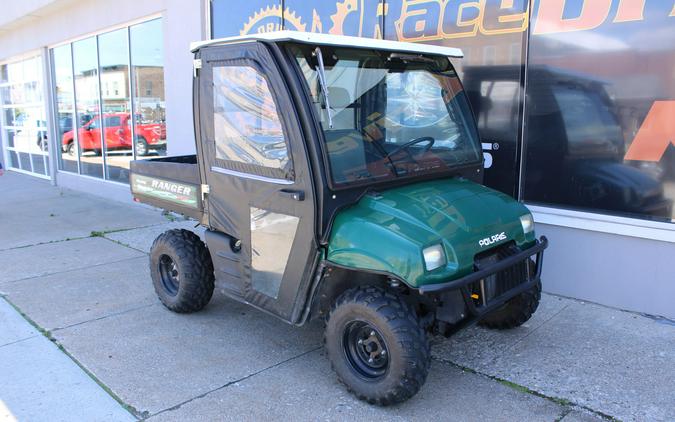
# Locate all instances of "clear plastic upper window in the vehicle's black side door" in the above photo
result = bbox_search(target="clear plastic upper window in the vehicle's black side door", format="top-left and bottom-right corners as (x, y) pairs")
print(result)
(213, 66), (290, 172)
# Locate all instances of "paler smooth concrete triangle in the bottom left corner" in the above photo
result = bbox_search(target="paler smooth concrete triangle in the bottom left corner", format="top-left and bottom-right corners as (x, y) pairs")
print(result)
(0, 298), (134, 421)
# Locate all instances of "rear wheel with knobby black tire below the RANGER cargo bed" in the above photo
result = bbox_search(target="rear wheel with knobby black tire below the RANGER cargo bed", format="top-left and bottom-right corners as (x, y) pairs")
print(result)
(150, 229), (214, 313)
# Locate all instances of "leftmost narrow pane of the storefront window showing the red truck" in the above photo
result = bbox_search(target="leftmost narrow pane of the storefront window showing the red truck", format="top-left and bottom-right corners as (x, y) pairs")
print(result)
(52, 44), (77, 173)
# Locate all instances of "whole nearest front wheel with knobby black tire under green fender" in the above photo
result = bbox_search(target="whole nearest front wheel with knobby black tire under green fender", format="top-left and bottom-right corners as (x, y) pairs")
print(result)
(325, 287), (430, 406)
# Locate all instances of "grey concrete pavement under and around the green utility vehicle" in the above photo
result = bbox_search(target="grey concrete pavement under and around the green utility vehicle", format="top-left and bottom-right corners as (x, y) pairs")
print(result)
(0, 173), (675, 422)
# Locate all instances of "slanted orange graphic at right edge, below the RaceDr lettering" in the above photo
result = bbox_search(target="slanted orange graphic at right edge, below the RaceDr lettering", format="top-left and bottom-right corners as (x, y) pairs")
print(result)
(624, 101), (675, 161)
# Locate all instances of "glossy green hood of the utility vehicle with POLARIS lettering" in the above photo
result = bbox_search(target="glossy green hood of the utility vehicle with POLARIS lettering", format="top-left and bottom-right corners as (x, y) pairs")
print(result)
(328, 179), (534, 287)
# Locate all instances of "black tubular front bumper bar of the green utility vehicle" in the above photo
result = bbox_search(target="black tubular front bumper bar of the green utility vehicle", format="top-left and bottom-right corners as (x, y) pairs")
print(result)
(418, 236), (548, 317)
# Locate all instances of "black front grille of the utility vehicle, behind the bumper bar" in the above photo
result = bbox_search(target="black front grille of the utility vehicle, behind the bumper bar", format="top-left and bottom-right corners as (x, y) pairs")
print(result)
(469, 242), (534, 306)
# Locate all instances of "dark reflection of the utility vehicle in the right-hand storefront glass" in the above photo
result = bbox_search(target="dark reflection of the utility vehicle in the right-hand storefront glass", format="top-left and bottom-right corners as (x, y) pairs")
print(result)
(524, 65), (673, 221)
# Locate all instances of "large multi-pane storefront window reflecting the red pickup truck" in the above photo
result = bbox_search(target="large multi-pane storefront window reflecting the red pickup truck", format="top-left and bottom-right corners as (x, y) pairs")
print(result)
(51, 19), (167, 183)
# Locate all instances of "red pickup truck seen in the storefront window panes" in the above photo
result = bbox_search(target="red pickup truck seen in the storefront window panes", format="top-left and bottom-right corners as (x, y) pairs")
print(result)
(61, 113), (166, 155)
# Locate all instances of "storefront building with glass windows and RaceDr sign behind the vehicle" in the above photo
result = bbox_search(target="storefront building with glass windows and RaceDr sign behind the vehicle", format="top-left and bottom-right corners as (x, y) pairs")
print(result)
(0, 0), (675, 318)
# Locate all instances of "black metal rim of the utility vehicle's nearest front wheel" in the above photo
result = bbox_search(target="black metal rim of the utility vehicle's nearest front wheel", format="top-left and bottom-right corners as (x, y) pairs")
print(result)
(342, 321), (389, 380)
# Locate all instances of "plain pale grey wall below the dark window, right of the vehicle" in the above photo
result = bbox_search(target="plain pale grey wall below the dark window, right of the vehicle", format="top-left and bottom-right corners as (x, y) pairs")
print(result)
(537, 224), (675, 319)
